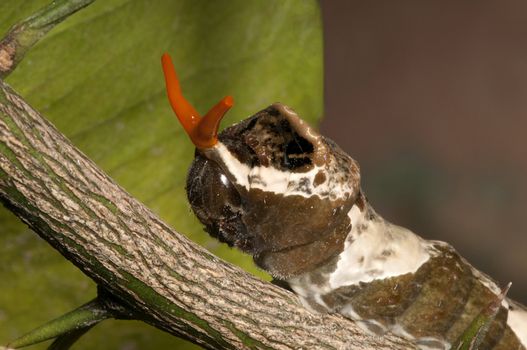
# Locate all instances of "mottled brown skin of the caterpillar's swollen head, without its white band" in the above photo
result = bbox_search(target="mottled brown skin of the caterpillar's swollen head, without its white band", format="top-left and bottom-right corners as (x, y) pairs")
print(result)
(187, 103), (359, 279)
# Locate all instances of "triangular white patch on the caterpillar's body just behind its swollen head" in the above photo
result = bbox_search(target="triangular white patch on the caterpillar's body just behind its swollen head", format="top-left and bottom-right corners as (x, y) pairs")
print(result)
(329, 205), (431, 289)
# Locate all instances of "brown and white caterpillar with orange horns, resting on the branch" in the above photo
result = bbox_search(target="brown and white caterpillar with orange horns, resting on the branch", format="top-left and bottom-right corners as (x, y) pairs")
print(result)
(162, 54), (527, 350)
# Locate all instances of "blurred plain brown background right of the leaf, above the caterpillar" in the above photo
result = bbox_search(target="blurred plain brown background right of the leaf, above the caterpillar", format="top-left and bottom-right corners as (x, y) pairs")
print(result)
(321, 0), (527, 303)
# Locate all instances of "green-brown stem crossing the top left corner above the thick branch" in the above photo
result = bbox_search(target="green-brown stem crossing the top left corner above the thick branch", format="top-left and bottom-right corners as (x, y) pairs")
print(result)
(0, 0), (95, 79)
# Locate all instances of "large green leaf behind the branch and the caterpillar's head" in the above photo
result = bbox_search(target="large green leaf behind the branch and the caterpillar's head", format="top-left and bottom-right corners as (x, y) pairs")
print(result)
(0, 0), (322, 349)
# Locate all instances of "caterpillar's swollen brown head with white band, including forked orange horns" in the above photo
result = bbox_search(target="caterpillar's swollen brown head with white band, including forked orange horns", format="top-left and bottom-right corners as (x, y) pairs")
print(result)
(163, 55), (360, 279)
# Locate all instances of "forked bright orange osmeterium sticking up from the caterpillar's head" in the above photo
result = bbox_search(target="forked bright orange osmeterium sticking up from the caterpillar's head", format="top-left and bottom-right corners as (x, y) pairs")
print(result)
(161, 53), (234, 148)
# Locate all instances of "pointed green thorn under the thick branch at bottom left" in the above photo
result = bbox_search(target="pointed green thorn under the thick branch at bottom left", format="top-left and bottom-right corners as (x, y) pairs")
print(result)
(7, 299), (112, 349)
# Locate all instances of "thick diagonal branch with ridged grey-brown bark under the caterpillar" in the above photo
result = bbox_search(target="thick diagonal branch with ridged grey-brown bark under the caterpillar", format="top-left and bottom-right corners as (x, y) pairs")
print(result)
(0, 81), (414, 349)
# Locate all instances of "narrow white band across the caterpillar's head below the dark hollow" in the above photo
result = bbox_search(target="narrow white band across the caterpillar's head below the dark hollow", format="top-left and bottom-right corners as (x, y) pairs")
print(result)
(210, 142), (354, 200)
